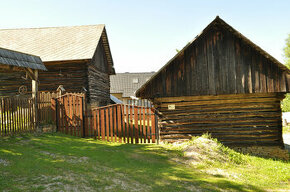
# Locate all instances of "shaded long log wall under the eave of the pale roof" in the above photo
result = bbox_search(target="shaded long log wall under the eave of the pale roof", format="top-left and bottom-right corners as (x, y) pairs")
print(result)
(0, 61), (88, 96)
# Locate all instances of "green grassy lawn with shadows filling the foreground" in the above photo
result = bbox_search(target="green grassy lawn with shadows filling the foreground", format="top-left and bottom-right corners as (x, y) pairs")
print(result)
(0, 134), (290, 191)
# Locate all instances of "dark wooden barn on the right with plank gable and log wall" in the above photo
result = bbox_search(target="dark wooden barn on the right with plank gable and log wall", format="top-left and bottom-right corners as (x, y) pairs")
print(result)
(136, 17), (290, 147)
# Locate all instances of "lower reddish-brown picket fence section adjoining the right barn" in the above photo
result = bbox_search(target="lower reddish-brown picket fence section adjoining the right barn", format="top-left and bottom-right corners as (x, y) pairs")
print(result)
(91, 104), (159, 144)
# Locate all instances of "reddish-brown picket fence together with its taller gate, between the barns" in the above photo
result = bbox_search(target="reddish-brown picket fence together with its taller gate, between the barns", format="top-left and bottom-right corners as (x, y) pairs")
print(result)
(51, 93), (159, 143)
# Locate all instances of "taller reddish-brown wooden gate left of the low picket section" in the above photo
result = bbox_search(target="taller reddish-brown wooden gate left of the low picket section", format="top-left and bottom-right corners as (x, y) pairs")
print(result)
(51, 93), (85, 137)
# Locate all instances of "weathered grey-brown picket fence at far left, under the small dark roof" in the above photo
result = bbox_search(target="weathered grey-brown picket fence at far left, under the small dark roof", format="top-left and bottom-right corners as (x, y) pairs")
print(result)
(0, 96), (35, 136)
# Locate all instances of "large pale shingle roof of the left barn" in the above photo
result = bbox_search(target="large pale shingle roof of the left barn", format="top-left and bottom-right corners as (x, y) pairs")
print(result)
(0, 24), (113, 73)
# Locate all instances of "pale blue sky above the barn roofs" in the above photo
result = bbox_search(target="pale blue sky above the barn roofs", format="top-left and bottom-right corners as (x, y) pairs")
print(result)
(0, 0), (290, 72)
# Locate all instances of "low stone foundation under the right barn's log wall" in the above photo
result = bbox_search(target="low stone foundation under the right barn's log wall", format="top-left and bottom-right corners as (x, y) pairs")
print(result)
(232, 146), (289, 161)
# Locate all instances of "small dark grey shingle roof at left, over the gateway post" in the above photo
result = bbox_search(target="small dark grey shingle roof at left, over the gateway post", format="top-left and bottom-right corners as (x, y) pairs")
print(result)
(0, 48), (47, 71)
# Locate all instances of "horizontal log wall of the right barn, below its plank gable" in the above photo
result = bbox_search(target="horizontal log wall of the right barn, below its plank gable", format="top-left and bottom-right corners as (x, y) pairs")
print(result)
(154, 93), (284, 146)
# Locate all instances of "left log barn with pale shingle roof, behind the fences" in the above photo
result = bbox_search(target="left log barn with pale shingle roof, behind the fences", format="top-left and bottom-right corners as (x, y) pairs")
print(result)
(0, 25), (115, 106)
